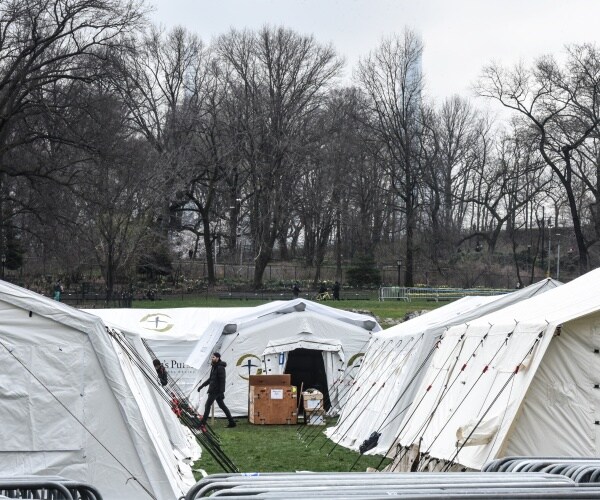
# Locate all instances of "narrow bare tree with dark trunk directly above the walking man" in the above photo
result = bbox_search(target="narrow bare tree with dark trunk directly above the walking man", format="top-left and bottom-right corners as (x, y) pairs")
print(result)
(171, 54), (237, 284)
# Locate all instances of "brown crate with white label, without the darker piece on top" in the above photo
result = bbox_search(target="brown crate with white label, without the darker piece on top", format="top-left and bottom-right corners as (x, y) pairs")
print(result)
(248, 385), (298, 425)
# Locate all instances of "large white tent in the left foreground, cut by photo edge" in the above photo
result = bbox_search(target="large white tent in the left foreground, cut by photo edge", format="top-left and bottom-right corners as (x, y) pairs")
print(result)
(0, 282), (199, 499)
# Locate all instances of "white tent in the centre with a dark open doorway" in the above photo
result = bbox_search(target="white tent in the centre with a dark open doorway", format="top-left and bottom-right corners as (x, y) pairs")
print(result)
(187, 299), (381, 415)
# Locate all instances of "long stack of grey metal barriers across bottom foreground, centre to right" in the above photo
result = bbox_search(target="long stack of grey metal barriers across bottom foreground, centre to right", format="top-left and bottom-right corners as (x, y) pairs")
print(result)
(185, 472), (600, 500)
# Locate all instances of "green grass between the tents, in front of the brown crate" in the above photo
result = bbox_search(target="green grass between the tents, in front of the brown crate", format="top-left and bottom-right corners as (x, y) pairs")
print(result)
(195, 418), (388, 474)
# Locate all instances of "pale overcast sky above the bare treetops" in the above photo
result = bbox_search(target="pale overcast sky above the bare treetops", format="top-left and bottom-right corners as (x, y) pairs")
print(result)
(148, 0), (600, 106)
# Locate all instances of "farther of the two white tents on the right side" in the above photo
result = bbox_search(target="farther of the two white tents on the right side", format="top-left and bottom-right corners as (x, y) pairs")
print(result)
(326, 279), (559, 454)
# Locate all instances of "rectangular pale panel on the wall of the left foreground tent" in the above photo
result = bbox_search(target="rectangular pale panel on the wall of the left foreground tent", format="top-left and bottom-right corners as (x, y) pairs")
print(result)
(0, 345), (84, 451)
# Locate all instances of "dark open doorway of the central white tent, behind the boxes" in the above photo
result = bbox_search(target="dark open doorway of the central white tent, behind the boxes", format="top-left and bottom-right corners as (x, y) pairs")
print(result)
(284, 349), (331, 410)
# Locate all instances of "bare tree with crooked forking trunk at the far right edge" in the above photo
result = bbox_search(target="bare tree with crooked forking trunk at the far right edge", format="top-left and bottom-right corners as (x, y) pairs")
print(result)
(479, 44), (600, 272)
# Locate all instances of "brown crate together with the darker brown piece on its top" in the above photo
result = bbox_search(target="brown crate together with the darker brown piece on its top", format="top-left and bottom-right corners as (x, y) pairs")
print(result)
(248, 374), (298, 425)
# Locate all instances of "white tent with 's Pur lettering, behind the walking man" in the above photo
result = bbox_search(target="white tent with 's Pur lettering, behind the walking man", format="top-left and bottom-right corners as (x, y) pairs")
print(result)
(85, 307), (253, 395)
